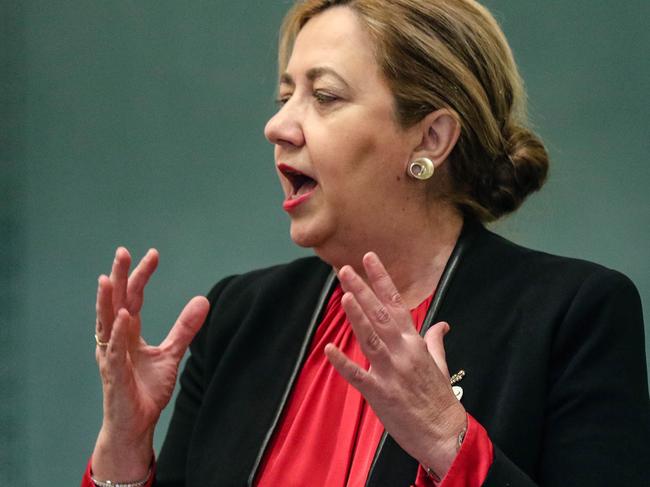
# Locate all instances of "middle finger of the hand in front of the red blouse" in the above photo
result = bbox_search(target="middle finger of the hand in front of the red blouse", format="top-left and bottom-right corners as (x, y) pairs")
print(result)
(339, 266), (402, 350)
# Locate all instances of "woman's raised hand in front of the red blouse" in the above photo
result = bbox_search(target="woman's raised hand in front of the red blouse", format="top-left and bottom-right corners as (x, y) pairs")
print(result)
(325, 252), (467, 478)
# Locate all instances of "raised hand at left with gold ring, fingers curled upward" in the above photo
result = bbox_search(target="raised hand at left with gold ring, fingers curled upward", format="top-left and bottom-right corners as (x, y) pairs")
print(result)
(92, 247), (210, 482)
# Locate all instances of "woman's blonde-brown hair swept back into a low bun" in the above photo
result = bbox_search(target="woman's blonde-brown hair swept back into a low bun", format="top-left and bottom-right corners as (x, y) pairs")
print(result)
(279, 0), (548, 221)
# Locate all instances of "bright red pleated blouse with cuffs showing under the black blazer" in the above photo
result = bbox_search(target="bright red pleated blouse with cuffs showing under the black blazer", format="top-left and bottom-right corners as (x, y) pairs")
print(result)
(81, 286), (493, 487)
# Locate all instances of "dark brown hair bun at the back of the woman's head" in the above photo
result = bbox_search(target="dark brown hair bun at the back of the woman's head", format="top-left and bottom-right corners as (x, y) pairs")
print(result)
(480, 126), (549, 220)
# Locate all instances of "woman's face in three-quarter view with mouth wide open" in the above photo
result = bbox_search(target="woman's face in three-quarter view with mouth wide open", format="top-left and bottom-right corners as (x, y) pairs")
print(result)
(265, 7), (421, 260)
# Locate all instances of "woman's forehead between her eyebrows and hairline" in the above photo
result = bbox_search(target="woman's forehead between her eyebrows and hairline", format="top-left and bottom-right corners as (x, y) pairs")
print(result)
(286, 7), (379, 82)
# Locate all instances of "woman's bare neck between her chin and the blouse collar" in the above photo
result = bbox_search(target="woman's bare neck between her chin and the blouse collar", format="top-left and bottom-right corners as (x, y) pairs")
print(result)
(315, 207), (463, 309)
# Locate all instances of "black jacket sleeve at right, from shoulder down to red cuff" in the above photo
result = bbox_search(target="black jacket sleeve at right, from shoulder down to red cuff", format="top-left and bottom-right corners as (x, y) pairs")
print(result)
(483, 268), (650, 487)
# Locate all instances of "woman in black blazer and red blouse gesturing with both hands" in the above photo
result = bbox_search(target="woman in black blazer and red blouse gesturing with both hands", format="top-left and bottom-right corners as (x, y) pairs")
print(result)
(84, 0), (650, 487)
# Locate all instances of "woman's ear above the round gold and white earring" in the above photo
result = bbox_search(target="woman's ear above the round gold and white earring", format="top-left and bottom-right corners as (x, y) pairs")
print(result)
(413, 108), (460, 168)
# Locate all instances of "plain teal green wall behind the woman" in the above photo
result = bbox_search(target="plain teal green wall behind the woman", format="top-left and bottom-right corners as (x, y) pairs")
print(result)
(0, 0), (650, 487)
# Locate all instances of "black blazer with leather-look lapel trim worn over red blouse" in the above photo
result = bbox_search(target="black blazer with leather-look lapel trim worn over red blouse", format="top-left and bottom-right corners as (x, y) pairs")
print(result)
(155, 224), (650, 487)
